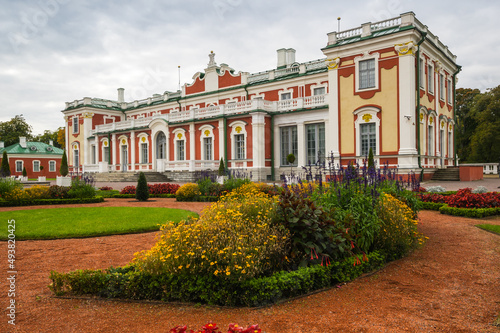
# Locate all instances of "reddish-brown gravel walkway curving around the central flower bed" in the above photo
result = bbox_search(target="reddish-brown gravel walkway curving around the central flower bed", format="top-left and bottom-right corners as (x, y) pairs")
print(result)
(0, 199), (500, 333)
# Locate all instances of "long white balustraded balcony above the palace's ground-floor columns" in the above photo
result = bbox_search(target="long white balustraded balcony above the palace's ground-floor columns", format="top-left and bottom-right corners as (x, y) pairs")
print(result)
(91, 95), (327, 135)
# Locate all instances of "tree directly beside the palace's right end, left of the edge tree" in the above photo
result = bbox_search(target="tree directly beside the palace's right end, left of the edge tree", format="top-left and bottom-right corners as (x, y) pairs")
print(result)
(455, 88), (481, 163)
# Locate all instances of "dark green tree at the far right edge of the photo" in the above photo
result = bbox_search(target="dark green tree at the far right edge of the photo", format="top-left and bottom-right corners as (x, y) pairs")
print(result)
(470, 86), (500, 163)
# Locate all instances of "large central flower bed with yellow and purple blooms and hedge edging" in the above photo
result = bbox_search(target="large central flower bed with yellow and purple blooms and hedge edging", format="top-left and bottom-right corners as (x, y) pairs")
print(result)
(51, 161), (424, 306)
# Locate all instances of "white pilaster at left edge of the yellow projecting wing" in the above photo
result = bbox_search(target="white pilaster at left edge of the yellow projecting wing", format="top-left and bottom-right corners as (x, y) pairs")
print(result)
(326, 58), (340, 158)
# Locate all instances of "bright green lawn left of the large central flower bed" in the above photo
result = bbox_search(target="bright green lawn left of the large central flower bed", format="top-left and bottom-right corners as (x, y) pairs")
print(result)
(0, 207), (197, 240)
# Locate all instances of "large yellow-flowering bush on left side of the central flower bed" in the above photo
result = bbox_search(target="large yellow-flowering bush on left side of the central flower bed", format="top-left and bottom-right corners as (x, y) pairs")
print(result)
(133, 184), (289, 280)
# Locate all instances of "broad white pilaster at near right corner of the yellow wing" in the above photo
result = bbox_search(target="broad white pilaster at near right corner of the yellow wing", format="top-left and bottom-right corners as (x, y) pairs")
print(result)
(396, 48), (420, 168)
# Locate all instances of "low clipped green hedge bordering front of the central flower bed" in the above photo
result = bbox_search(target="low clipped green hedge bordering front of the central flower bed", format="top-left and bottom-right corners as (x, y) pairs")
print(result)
(50, 252), (385, 307)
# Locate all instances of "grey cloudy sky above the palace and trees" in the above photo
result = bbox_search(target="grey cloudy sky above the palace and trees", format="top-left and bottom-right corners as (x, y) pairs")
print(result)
(0, 0), (500, 135)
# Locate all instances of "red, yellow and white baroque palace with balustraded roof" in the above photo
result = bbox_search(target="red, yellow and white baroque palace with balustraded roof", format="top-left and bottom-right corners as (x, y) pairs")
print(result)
(62, 12), (460, 180)
